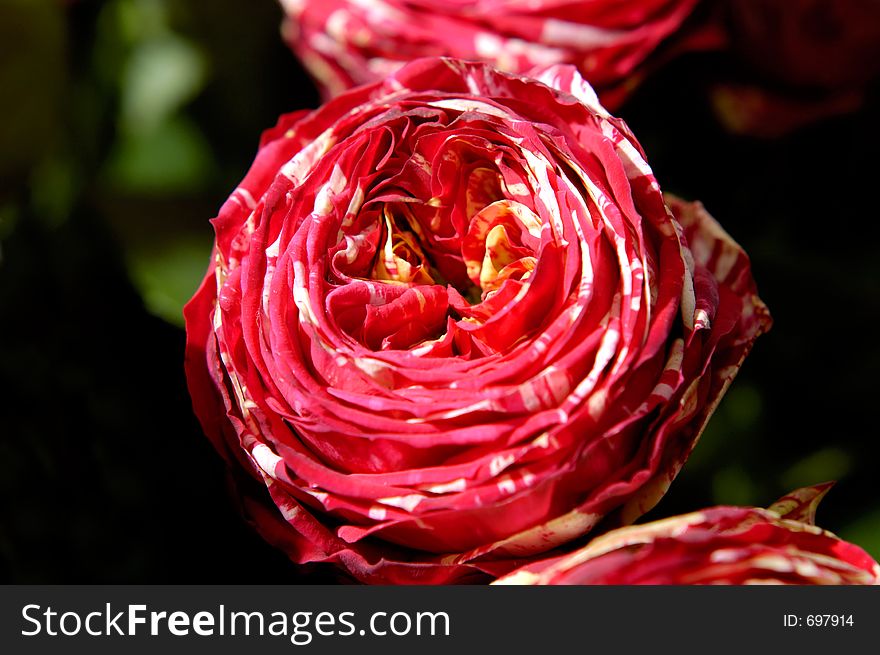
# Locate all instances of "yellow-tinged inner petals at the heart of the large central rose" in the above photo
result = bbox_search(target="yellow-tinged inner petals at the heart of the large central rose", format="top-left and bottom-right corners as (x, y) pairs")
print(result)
(334, 134), (542, 356)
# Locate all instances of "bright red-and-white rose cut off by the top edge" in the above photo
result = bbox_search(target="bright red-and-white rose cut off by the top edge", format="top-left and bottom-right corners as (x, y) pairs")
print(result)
(281, 0), (702, 106)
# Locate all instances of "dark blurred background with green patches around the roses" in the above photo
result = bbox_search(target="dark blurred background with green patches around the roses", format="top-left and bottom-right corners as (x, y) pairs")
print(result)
(0, 0), (880, 583)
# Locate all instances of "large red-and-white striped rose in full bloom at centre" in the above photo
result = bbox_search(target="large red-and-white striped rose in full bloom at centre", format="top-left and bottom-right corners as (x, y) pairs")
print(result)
(185, 59), (770, 583)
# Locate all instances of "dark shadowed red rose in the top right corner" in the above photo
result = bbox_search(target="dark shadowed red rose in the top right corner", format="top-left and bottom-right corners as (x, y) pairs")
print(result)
(711, 0), (880, 137)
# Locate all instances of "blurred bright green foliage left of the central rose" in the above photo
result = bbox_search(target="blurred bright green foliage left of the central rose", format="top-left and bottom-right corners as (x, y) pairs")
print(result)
(95, 0), (217, 325)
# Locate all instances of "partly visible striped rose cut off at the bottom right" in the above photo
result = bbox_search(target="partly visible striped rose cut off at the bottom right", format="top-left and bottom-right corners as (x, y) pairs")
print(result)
(496, 484), (880, 585)
